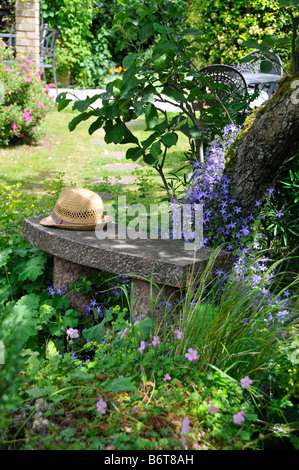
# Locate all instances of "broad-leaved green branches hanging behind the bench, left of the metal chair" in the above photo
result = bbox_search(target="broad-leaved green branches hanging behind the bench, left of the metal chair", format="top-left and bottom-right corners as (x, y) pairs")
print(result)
(57, 0), (254, 199)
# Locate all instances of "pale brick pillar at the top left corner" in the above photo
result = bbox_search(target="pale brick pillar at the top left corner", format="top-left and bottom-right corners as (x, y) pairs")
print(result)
(15, 0), (40, 69)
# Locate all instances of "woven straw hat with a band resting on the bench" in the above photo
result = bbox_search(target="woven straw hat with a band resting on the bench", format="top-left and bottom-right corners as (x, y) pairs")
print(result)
(40, 187), (113, 230)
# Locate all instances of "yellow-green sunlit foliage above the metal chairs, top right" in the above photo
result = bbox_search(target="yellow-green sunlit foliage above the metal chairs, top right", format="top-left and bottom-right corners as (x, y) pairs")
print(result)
(189, 0), (290, 66)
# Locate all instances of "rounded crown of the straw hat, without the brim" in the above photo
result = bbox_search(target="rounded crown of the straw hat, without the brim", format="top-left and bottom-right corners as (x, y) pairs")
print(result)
(54, 187), (104, 224)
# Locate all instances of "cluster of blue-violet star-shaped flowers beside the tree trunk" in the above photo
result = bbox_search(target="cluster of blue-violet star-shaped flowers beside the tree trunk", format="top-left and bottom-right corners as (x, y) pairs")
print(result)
(175, 125), (298, 326)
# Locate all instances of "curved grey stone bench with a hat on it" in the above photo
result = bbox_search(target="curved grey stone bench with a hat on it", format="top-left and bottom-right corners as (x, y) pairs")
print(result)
(22, 218), (229, 318)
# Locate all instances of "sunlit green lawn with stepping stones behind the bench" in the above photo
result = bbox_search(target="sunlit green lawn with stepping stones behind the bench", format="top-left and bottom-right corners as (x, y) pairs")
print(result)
(0, 110), (190, 207)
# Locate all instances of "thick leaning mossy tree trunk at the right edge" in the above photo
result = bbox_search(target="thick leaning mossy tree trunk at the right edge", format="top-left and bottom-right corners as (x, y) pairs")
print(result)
(226, 79), (299, 213)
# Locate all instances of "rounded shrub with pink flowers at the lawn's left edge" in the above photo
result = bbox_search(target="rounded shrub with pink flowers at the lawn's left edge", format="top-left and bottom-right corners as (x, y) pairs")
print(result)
(0, 43), (54, 146)
